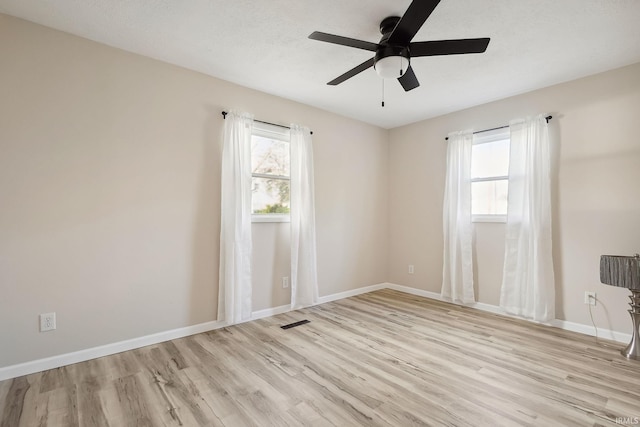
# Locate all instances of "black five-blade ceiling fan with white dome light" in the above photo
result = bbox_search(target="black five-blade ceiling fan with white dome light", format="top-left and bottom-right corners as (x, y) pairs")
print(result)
(309, 0), (490, 92)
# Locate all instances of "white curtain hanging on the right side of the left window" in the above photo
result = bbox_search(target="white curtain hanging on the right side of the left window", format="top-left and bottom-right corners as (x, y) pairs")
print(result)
(291, 125), (318, 310)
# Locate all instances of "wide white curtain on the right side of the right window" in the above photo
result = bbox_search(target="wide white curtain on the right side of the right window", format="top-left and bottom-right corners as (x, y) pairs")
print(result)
(500, 115), (555, 322)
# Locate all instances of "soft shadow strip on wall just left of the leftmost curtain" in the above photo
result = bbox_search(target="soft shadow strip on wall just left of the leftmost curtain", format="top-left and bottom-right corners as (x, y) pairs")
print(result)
(188, 105), (224, 324)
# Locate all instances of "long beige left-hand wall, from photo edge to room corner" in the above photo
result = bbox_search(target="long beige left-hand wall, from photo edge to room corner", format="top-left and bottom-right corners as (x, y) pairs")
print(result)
(0, 15), (389, 367)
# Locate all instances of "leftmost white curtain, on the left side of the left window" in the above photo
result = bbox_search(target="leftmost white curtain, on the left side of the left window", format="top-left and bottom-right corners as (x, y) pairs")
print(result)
(218, 111), (253, 324)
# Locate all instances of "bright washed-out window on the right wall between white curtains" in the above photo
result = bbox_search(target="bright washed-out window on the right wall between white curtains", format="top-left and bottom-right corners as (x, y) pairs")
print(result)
(471, 128), (510, 222)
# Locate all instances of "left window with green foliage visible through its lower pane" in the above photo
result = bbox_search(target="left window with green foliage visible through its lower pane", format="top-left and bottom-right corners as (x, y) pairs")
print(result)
(251, 122), (290, 222)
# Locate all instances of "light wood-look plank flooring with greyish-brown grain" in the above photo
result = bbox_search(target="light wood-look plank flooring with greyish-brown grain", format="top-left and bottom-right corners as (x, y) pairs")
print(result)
(0, 290), (640, 427)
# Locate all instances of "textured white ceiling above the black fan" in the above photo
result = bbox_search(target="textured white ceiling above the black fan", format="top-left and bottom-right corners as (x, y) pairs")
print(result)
(0, 0), (640, 128)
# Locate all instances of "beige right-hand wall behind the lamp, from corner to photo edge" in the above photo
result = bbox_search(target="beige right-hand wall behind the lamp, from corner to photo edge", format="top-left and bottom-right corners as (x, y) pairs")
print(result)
(389, 64), (640, 333)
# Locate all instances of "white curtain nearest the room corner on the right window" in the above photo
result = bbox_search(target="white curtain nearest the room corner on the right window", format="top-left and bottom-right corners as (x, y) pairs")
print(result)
(441, 131), (475, 304)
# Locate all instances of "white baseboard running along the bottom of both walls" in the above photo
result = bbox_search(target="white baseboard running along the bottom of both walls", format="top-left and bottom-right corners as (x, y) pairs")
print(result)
(0, 283), (631, 381)
